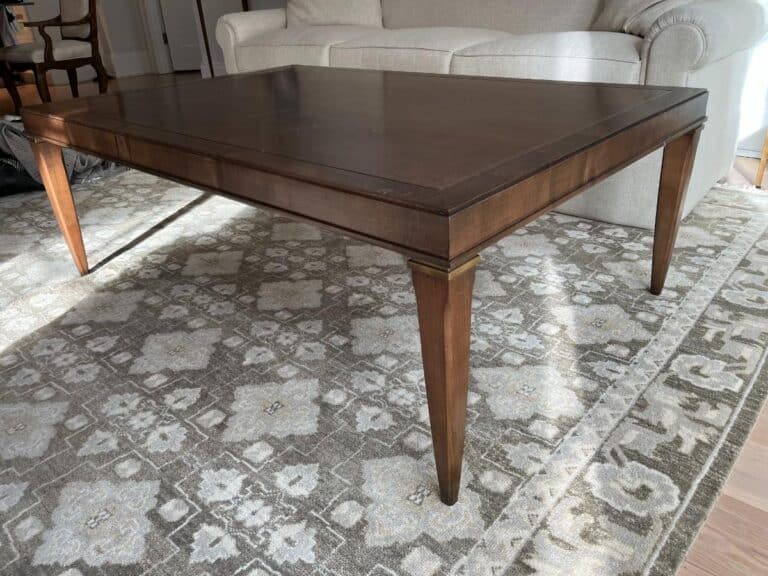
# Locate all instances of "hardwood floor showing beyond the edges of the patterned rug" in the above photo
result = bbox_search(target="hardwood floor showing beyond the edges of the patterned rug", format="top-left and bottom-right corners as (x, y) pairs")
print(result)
(0, 73), (768, 576)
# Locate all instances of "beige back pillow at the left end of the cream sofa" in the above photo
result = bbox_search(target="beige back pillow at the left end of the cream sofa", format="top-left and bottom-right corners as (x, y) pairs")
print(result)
(287, 0), (382, 28)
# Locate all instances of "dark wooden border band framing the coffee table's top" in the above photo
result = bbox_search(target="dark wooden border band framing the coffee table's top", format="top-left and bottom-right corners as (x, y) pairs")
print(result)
(22, 65), (707, 216)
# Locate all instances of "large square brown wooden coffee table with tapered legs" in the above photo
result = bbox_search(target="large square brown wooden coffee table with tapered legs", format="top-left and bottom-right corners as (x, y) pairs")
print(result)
(22, 66), (707, 504)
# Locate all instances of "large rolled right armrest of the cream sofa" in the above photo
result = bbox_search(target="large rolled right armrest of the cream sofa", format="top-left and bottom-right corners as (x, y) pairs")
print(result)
(641, 0), (768, 85)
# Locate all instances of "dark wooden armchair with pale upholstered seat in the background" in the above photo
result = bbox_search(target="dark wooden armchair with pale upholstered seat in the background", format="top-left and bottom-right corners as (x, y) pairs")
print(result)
(0, 0), (108, 112)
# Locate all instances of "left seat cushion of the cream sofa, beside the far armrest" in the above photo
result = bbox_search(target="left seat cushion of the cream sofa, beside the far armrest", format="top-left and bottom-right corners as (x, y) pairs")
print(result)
(235, 26), (376, 72)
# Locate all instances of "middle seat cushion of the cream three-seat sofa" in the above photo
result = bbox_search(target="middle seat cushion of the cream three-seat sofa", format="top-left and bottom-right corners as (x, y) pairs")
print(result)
(331, 28), (507, 74)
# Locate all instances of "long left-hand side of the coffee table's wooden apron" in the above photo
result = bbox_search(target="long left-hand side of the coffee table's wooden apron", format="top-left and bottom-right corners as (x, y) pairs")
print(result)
(25, 114), (456, 268)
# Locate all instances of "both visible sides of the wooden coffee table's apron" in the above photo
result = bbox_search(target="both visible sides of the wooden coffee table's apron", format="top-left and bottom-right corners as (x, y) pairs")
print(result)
(24, 98), (706, 270)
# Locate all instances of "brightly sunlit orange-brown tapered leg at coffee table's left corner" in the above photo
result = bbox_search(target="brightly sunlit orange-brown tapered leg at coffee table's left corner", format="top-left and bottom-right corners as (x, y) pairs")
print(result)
(32, 142), (88, 276)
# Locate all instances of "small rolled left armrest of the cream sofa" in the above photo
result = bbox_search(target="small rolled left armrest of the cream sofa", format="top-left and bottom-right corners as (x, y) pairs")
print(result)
(216, 8), (287, 74)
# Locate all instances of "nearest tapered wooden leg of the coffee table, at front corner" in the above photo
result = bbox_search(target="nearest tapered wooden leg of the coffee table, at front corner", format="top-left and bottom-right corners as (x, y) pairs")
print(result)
(410, 257), (479, 506)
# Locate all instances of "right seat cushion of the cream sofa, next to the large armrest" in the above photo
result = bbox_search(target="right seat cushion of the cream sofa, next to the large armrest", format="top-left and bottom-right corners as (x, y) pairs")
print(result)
(451, 32), (643, 84)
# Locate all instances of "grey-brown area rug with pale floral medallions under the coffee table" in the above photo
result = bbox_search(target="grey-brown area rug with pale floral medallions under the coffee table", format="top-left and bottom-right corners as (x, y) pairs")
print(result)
(0, 172), (768, 576)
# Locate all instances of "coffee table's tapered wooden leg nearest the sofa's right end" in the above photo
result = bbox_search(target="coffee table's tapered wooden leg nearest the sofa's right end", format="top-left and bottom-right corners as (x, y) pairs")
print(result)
(651, 129), (701, 295)
